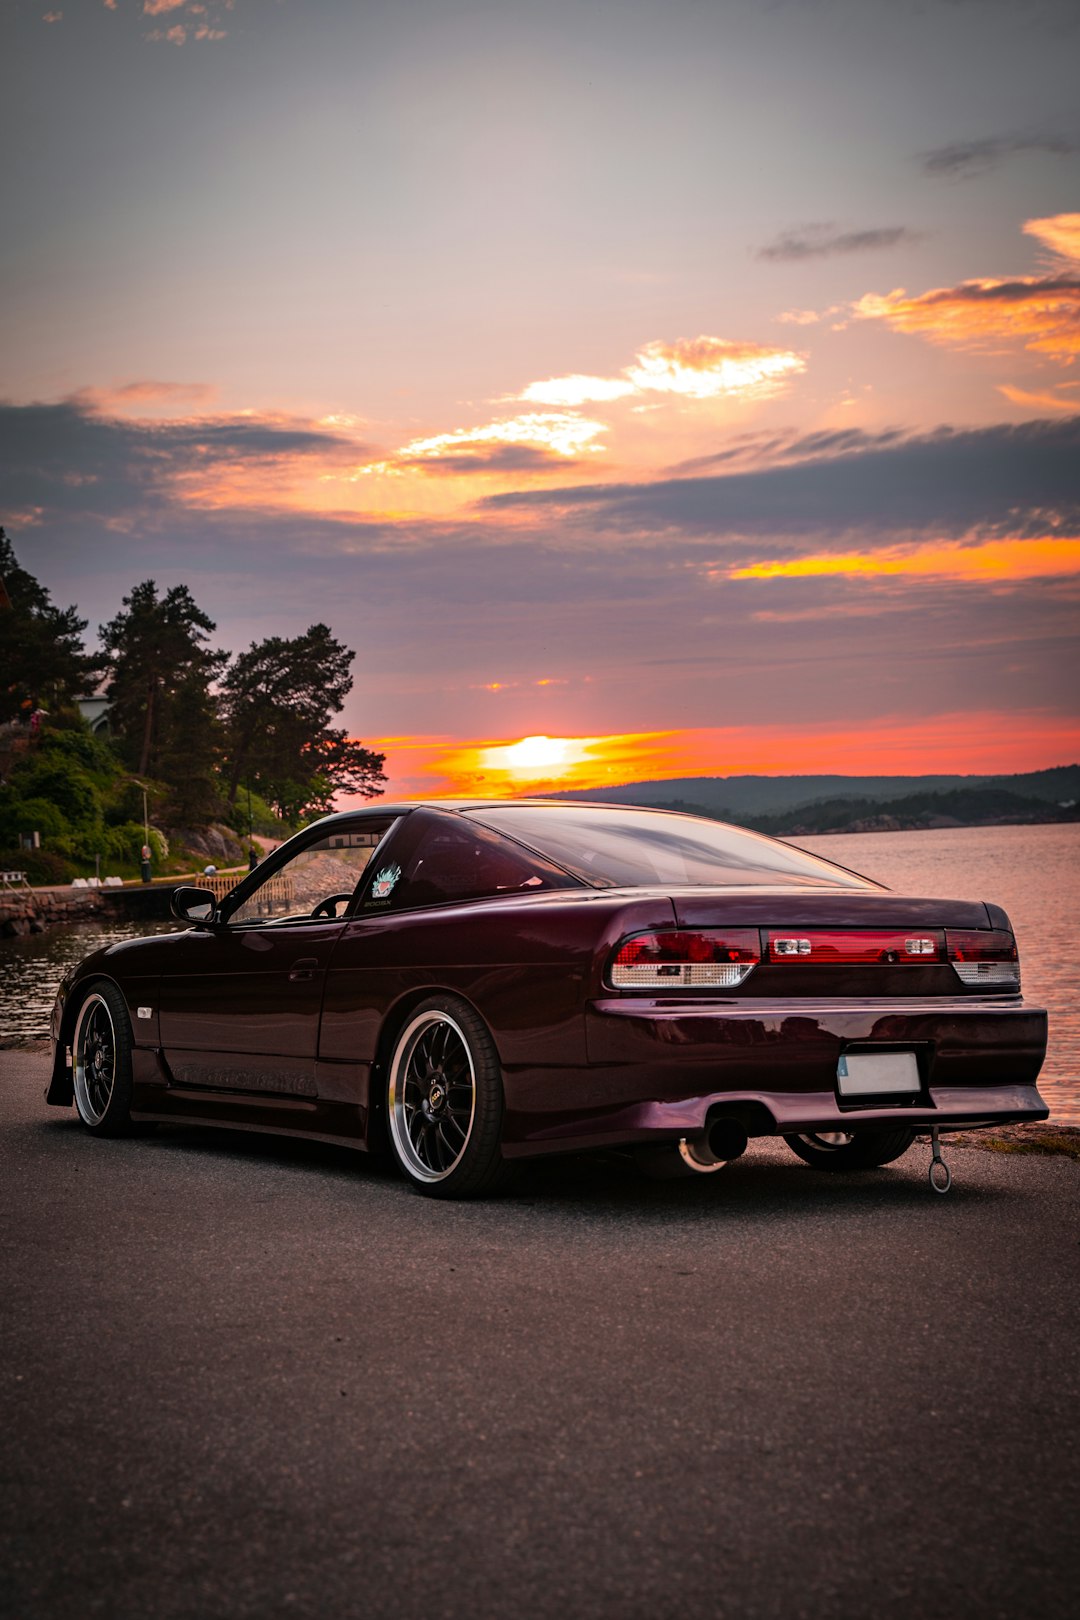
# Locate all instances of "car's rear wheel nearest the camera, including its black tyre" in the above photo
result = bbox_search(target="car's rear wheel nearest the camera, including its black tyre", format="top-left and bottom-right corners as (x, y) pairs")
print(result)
(387, 996), (504, 1197)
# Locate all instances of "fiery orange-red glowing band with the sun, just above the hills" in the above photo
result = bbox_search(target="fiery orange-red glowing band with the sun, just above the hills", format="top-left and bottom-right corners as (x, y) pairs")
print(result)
(369, 710), (1080, 799)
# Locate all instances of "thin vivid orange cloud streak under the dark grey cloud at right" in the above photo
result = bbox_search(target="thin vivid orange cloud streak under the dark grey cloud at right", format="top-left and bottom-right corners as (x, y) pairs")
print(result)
(722, 538), (1080, 585)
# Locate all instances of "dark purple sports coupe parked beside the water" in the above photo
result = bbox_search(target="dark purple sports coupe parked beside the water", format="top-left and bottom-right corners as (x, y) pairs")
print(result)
(47, 800), (1048, 1197)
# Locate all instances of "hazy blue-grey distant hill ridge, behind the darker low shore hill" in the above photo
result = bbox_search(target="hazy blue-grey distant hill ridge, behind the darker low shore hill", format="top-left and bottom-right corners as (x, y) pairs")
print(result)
(551, 765), (1080, 821)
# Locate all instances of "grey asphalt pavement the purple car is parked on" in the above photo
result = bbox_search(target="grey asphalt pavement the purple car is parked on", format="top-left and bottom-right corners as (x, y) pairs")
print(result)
(0, 1051), (1080, 1620)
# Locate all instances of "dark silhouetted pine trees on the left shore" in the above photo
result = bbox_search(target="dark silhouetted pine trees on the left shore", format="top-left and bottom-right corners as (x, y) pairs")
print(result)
(0, 528), (385, 874)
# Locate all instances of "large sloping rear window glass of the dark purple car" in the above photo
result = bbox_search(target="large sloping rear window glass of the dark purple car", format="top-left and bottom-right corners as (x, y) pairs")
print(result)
(466, 804), (881, 889)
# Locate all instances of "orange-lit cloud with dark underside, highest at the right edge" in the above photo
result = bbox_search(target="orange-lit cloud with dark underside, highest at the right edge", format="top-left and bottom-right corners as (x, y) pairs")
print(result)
(852, 214), (1080, 361)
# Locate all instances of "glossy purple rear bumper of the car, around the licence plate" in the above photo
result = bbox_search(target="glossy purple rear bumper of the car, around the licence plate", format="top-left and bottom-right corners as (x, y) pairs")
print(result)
(504, 996), (1049, 1157)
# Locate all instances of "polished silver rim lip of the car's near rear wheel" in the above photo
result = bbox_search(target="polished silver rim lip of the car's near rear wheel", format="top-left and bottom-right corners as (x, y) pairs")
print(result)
(387, 1008), (476, 1183)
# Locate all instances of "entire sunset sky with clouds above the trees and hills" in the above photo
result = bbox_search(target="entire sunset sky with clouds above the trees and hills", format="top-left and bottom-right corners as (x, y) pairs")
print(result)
(0, 0), (1080, 794)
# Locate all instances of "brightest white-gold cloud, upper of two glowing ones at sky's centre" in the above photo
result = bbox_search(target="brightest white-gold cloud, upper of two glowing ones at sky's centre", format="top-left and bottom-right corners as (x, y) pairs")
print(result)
(520, 337), (806, 405)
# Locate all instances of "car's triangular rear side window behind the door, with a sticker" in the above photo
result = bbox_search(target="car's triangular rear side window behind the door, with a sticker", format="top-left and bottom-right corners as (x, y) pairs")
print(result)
(361, 813), (580, 912)
